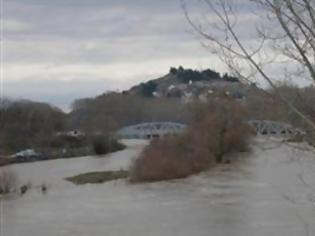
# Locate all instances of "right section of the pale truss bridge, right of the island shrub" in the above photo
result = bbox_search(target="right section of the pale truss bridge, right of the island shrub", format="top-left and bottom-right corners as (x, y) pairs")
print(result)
(248, 120), (305, 137)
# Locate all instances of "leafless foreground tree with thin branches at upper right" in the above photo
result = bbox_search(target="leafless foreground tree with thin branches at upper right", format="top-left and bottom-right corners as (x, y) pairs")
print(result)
(182, 0), (315, 132)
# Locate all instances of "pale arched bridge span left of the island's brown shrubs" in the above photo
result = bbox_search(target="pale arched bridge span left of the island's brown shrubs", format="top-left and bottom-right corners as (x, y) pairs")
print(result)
(116, 122), (186, 139)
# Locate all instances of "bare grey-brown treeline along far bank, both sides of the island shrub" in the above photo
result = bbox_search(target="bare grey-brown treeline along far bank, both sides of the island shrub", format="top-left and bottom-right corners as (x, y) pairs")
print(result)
(0, 84), (315, 156)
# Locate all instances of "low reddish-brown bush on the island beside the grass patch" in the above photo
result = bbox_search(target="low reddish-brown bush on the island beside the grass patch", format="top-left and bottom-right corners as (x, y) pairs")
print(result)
(130, 135), (213, 182)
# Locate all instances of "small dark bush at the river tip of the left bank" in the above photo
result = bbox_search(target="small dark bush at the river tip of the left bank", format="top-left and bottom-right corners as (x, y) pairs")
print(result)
(92, 135), (125, 155)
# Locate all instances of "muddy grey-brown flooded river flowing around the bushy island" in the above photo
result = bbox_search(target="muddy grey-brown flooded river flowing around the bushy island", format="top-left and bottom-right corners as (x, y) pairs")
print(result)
(1, 139), (315, 236)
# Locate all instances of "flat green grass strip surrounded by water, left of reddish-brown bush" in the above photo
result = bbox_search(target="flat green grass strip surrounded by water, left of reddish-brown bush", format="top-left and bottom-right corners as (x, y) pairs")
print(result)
(65, 170), (129, 185)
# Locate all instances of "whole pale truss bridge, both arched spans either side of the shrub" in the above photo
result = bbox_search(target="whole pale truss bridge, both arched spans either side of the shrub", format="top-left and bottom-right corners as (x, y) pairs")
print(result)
(116, 120), (305, 139)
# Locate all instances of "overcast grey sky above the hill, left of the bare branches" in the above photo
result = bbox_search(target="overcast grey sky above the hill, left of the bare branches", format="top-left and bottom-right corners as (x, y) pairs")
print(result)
(0, 0), (310, 109)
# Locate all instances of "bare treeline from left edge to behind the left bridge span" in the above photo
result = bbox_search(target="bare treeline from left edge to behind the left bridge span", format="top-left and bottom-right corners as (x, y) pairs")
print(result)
(0, 92), (189, 156)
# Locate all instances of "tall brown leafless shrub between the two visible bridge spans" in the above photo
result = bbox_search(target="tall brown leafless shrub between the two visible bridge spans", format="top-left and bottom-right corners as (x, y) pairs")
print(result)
(190, 99), (251, 162)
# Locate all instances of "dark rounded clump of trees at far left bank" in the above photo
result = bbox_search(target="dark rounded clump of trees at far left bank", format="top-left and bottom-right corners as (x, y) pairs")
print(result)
(0, 99), (67, 154)
